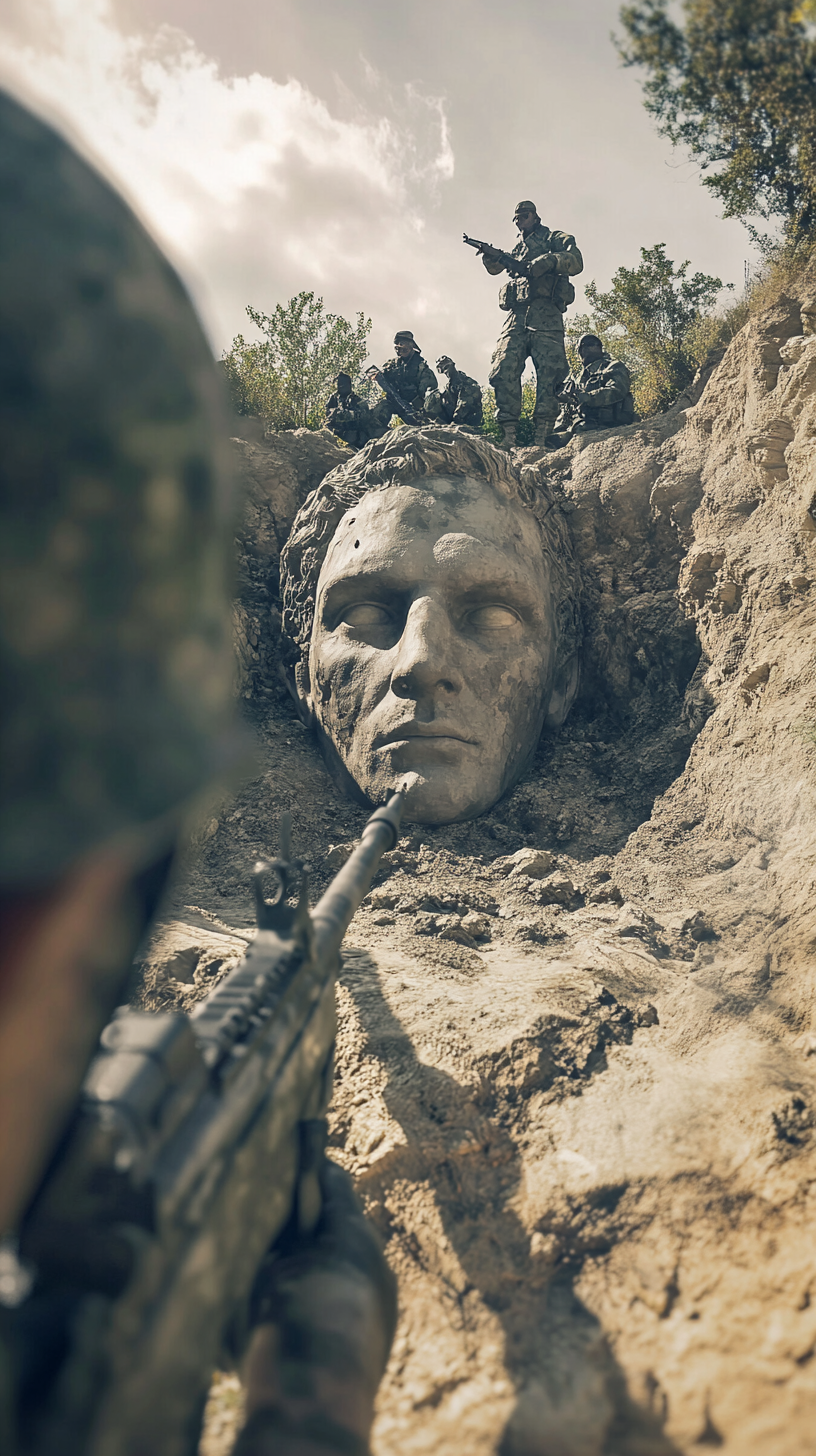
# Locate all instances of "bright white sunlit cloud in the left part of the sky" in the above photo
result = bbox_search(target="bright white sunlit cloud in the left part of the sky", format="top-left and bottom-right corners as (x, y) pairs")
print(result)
(0, 0), (455, 351)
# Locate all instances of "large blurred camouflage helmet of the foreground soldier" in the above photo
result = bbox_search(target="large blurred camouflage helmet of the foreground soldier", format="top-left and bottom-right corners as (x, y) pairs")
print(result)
(0, 93), (240, 891)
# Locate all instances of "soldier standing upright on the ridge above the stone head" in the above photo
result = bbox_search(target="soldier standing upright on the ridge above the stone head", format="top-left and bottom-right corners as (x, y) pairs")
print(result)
(482, 201), (584, 447)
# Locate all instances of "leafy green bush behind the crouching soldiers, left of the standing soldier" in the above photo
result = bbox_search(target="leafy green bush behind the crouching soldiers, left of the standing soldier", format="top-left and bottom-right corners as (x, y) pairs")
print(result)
(223, 293), (372, 430)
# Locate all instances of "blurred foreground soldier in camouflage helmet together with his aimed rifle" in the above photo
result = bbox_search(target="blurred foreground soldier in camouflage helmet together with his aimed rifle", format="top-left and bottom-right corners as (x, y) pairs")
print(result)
(0, 95), (399, 1456)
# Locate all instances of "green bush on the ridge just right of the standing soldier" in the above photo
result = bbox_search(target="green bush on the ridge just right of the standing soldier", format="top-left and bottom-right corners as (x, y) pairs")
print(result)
(567, 243), (723, 416)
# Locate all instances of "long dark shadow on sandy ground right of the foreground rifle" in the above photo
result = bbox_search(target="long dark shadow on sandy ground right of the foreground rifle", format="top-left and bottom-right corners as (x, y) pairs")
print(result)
(335, 951), (679, 1456)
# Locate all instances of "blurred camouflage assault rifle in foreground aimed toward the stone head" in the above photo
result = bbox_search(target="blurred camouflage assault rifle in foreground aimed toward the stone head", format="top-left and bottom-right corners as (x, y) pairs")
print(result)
(0, 794), (404, 1456)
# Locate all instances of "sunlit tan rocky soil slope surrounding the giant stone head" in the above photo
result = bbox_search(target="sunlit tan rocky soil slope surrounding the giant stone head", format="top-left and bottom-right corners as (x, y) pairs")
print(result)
(144, 286), (816, 1456)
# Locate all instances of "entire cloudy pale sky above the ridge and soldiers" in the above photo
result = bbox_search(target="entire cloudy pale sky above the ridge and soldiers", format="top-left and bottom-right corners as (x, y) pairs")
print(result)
(0, 0), (752, 383)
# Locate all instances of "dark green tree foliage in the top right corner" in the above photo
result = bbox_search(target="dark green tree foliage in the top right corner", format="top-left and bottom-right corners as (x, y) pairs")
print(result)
(615, 0), (816, 245)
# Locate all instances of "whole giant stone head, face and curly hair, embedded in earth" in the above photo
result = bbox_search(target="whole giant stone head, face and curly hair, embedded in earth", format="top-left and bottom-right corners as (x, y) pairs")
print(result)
(281, 428), (580, 824)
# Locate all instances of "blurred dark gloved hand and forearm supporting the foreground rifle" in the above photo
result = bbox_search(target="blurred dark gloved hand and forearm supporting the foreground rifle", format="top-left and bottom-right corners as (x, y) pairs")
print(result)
(233, 1160), (396, 1456)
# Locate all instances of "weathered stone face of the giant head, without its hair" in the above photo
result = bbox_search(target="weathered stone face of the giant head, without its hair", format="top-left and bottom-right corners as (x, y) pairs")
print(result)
(309, 471), (557, 824)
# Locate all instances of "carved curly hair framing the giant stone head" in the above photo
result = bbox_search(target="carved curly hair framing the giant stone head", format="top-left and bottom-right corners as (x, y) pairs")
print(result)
(281, 425), (581, 664)
